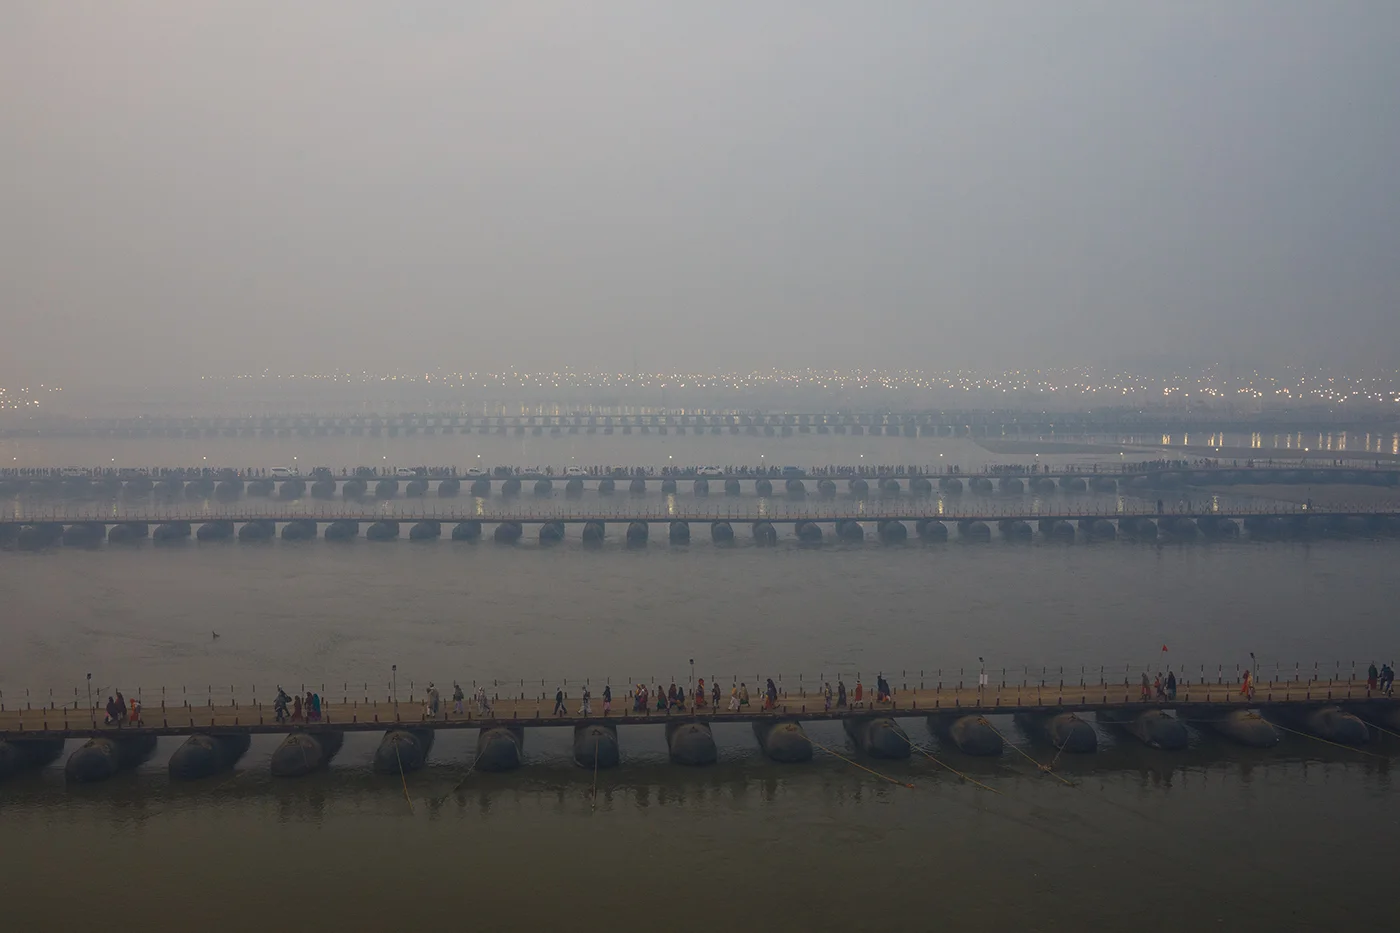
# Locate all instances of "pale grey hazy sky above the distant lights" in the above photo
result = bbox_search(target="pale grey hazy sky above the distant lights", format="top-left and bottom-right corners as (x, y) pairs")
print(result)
(0, 0), (1400, 385)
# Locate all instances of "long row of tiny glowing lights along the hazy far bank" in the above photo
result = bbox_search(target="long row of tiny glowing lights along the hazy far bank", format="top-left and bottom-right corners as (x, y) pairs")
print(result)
(200, 370), (1400, 402)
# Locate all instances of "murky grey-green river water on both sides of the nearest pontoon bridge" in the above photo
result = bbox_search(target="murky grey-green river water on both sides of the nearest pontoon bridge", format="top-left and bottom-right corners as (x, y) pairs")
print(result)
(0, 438), (1400, 930)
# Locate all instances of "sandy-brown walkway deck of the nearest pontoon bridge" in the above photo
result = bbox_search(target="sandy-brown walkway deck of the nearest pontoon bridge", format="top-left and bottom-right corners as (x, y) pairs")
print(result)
(0, 681), (1400, 738)
